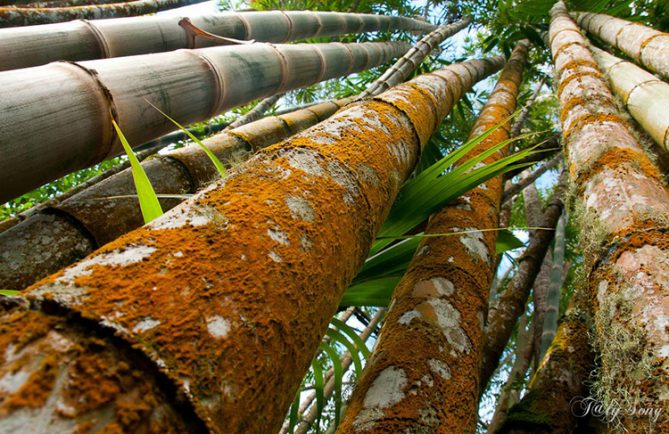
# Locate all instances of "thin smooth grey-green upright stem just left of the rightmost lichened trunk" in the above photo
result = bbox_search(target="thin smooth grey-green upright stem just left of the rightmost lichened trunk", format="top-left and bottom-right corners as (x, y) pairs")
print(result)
(539, 212), (567, 360)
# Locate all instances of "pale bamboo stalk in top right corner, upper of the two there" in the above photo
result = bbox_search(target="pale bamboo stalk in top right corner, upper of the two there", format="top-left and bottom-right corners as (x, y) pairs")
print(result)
(571, 12), (669, 79)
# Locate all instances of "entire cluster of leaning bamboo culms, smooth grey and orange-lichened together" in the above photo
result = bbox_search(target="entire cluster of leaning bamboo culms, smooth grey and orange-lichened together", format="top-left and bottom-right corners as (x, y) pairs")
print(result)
(0, 2), (669, 434)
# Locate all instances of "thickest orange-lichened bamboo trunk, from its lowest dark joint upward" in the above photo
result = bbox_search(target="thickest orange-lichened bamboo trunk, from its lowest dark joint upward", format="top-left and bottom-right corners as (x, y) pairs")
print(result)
(6, 58), (503, 434)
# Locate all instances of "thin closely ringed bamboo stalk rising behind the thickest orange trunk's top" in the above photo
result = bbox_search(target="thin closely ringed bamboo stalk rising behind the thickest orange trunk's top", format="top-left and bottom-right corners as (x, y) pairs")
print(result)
(360, 18), (472, 98)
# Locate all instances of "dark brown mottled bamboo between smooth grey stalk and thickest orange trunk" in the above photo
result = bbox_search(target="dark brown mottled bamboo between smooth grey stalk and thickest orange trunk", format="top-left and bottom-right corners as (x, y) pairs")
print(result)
(0, 100), (349, 290)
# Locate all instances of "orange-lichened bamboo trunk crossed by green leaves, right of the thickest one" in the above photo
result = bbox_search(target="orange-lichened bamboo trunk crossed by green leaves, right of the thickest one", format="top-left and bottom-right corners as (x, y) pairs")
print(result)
(338, 41), (528, 433)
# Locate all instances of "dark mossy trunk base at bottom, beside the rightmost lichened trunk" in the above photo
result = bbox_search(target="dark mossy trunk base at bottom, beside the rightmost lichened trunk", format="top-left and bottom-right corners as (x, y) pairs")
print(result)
(495, 287), (594, 434)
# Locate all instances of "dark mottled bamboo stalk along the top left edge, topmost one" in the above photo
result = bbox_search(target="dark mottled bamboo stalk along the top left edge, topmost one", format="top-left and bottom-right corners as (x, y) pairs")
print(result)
(0, 0), (206, 27)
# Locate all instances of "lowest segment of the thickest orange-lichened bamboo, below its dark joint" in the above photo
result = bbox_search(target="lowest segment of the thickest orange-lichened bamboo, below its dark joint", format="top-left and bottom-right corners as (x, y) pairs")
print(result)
(0, 300), (202, 434)
